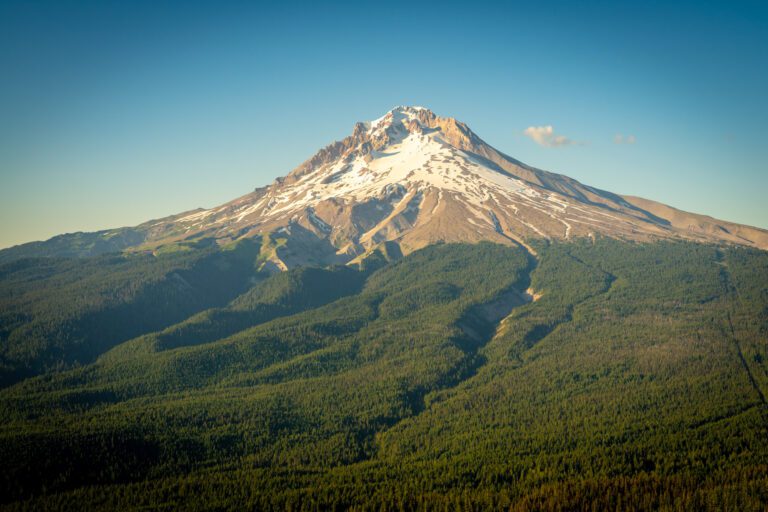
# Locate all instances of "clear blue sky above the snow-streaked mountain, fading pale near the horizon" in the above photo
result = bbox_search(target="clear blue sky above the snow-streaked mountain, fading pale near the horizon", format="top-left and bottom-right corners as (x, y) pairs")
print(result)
(0, 0), (768, 247)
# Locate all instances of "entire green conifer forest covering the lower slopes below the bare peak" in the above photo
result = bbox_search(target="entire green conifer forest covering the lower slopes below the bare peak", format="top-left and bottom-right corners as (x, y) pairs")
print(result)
(0, 239), (768, 511)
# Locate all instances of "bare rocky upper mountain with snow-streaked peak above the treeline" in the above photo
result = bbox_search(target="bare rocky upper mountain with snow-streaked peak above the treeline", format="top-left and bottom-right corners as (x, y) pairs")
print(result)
(129, 107), (768, 268)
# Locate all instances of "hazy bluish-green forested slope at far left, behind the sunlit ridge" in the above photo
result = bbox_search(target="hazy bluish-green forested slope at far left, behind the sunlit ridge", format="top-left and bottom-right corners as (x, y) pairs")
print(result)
(0, 240), (261, 386)
